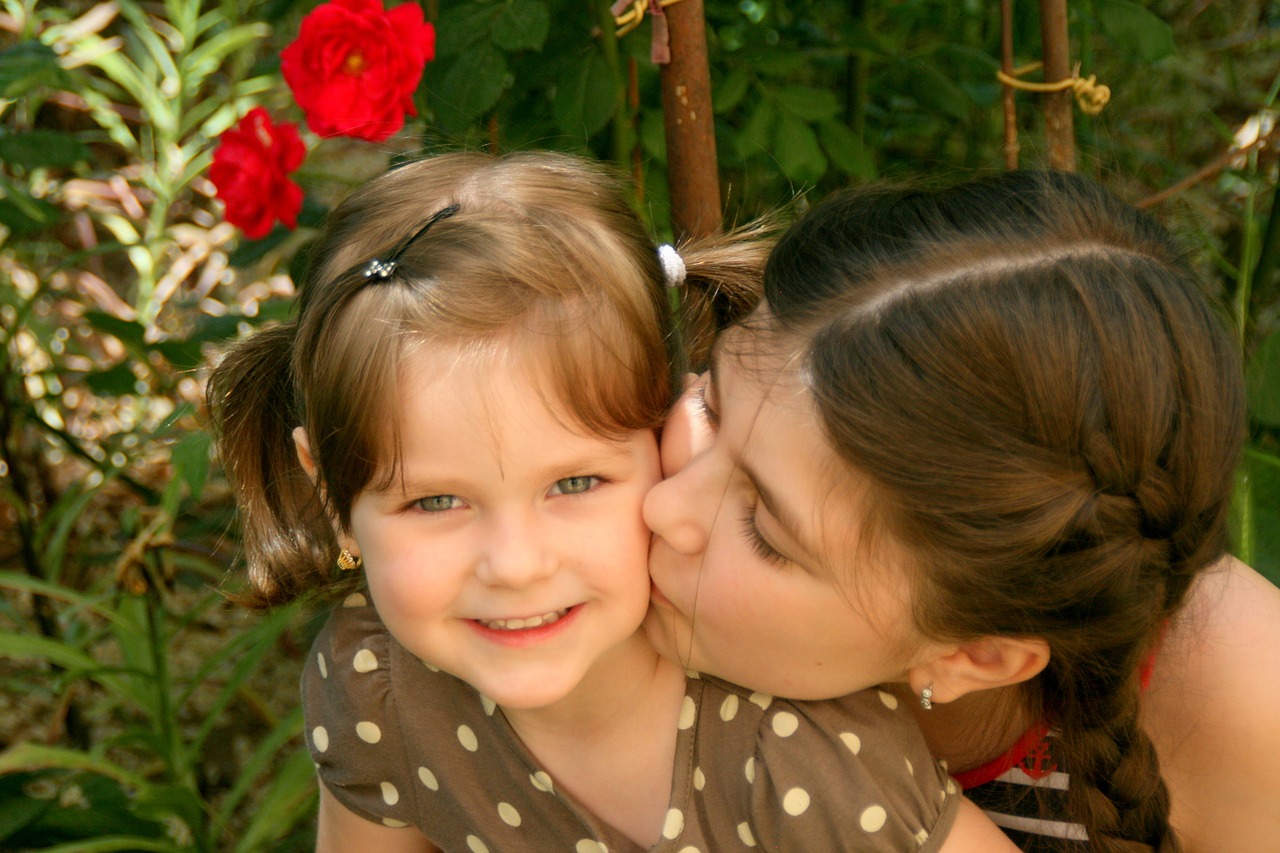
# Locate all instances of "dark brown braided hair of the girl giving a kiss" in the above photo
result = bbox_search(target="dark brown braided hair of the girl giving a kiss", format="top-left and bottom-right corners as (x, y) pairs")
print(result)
(764, 173), (1244, 852)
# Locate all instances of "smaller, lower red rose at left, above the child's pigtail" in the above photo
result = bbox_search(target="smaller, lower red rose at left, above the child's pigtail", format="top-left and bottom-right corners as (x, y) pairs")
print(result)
(209, 106), (307, 240)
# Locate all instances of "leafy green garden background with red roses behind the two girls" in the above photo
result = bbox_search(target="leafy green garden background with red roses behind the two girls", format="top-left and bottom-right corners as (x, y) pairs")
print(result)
(0, 0), (1280, 852)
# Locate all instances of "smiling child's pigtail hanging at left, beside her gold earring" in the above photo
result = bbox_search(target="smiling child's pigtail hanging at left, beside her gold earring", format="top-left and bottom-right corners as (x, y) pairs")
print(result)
(206, 323), (337, 606)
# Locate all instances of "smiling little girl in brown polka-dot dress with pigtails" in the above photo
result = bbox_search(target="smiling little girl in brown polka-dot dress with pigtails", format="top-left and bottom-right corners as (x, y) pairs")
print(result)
(209, 154), (998, 853)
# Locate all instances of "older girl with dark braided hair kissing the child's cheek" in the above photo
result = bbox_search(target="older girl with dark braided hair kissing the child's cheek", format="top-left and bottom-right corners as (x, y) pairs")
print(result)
(645, 173), (1280, 852)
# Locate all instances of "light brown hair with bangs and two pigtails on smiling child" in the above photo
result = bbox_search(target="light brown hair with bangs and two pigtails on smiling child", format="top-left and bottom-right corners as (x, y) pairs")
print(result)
(207, 152), (771, 605)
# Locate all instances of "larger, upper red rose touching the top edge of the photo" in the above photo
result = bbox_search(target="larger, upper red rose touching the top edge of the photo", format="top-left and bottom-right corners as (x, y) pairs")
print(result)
(280, 0), (435, 142)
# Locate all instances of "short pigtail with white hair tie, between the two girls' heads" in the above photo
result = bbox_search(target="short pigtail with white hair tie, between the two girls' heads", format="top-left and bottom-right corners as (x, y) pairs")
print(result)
(678, 216), (778, 373)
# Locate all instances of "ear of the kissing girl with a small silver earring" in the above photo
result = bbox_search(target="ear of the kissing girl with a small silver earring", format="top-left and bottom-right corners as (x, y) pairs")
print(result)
(908, 637), (1048, 702)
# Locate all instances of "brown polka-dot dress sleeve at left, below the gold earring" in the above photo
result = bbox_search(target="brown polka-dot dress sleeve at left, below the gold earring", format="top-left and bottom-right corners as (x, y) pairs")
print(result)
(302, 593), (413, 826)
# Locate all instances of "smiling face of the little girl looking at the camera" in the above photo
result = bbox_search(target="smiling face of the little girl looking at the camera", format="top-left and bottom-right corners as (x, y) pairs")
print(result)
(343, 347), (659, 708)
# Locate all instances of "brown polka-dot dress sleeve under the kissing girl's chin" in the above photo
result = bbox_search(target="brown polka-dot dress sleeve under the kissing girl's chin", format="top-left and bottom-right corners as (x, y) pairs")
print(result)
(748, 690), (960, 852)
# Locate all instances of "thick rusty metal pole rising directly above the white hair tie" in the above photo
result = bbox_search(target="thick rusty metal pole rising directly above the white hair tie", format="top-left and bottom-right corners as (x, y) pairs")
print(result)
(662, 0), (723, 237)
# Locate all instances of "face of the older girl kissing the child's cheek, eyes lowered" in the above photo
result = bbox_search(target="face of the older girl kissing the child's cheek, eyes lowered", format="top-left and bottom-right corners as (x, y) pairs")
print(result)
(644, 329), (925, 699)
